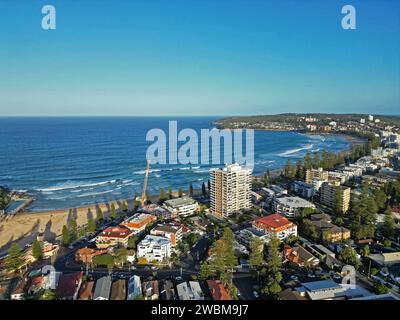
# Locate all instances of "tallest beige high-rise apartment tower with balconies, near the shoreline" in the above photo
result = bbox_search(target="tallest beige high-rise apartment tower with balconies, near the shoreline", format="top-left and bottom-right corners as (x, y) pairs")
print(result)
(210, 164), (252, 217)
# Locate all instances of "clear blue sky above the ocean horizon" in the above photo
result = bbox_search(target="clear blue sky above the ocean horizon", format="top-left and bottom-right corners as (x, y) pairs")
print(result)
(0, 0), (400, 116)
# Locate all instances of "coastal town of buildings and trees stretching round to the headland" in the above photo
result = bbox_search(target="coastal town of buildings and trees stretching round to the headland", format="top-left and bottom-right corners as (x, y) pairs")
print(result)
(0, 114), (400, 301)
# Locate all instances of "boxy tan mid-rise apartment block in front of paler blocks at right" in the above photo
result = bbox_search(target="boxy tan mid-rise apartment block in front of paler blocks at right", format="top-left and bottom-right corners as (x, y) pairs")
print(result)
(320, 182), (351, 213)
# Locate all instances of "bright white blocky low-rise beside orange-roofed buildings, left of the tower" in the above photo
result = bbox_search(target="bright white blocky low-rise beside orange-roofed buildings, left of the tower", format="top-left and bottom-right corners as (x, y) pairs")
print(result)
(136, 235), (171, 262)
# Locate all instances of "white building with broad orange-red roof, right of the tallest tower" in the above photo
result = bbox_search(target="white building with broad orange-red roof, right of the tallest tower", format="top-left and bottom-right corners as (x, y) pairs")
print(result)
(252, 213), (297, 240)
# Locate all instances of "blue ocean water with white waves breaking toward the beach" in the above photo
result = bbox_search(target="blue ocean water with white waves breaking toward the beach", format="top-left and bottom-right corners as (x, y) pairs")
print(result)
(0, 117), (349, 211)
